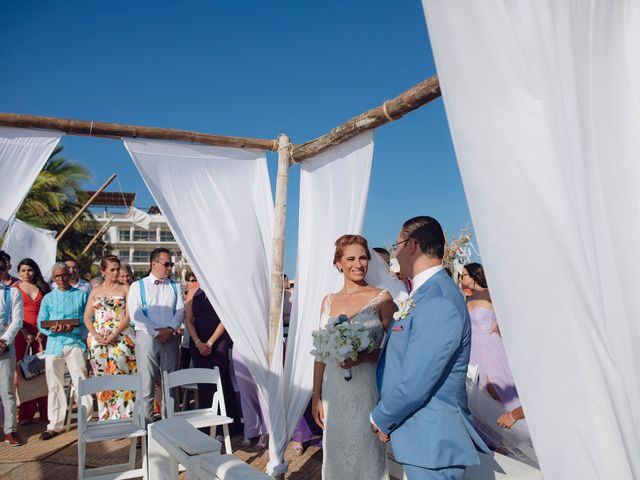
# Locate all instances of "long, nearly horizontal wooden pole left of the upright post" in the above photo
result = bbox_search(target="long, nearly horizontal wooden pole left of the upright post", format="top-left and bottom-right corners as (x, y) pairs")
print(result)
(0, 113), (277, 151)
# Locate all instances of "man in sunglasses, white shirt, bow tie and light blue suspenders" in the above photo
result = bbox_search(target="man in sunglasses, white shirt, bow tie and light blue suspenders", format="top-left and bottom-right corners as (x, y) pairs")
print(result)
(127, 248), (184, 423)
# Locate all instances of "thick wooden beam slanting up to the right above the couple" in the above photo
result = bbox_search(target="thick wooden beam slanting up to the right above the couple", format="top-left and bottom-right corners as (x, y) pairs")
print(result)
(291, 75), (441, 163)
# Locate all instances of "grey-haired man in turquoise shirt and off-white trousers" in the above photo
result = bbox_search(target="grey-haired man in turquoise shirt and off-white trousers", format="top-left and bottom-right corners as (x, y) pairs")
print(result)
(38, 263), (93, 440)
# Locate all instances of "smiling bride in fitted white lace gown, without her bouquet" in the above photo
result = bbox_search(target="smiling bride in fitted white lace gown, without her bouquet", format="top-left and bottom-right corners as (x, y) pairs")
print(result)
(312, 235), (396, 480)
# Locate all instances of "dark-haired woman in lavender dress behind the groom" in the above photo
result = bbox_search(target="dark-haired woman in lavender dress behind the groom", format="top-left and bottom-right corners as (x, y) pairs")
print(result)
(459, 263), (524, 448)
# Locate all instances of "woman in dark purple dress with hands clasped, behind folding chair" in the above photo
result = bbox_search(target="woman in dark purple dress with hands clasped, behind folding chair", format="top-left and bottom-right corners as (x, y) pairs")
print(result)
(184, 288), (239, 433)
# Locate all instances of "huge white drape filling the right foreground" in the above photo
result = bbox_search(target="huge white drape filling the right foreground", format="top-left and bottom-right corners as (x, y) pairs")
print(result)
(424, 0), (640, 479)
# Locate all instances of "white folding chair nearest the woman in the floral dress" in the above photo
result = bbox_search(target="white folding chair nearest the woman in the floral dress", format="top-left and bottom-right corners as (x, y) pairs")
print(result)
(78, 374), (148, 480)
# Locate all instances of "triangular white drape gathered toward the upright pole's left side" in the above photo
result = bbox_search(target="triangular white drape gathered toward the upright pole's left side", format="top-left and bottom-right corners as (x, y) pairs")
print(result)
(124, 139), (284, 464)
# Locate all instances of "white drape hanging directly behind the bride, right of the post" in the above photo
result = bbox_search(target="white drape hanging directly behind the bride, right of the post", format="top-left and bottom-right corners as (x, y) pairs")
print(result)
(279, 131), (374, 464)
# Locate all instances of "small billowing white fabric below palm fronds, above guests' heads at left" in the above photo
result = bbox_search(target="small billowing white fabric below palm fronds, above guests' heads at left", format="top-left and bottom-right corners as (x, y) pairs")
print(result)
(2, 218), (58, 281)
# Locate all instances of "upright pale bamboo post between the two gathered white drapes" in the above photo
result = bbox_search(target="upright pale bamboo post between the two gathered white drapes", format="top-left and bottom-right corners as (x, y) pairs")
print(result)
(268, 133), (291, 365)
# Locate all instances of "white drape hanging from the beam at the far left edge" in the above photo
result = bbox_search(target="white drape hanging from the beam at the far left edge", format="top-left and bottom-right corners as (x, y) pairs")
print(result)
(0, 127), (62, 235)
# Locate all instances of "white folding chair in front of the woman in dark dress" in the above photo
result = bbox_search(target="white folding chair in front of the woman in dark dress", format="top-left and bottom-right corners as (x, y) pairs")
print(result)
(162, 367), (233, 454)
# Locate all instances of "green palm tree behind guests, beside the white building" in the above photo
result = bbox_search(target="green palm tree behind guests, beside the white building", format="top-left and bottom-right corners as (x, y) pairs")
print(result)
(17, 145), (103, 271)
